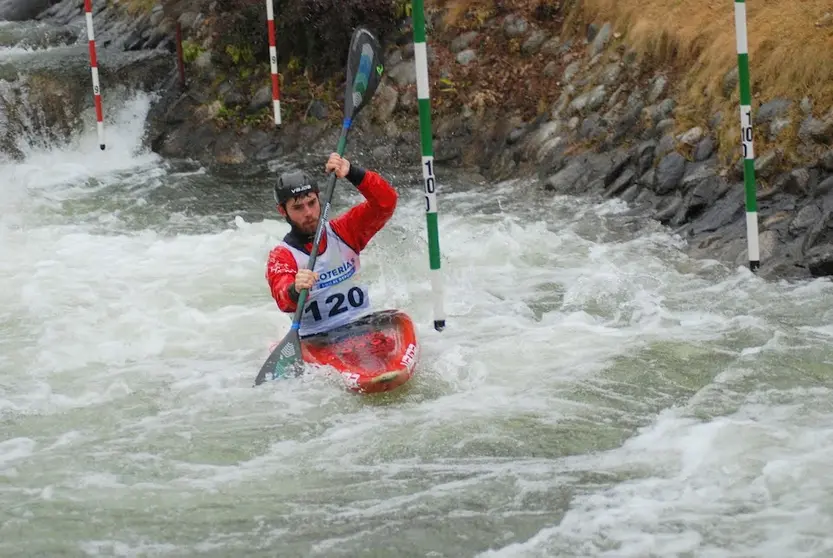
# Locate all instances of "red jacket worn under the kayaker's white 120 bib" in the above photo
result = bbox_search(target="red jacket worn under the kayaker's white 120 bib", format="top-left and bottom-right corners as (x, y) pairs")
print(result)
(266, 166), (398, 324)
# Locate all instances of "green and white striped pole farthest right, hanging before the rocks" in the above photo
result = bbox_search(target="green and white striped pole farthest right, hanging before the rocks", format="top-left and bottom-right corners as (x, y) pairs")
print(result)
(735, 0), (761, 271)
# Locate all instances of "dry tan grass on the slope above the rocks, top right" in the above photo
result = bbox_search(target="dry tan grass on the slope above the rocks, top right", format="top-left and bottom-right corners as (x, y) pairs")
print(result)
(584, 0), (833, 107)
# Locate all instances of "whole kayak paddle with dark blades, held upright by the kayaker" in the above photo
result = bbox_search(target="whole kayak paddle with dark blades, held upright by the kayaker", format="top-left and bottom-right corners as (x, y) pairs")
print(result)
(255, 27), (384, 386)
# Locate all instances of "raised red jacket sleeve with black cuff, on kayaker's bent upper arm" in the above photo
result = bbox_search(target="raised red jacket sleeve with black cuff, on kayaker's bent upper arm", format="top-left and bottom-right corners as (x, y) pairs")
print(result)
(330, 165), (398, 252)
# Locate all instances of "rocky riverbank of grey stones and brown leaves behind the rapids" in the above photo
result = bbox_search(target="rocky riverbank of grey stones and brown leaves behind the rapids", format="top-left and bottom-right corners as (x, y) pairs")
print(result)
(6, 2), (833, 277)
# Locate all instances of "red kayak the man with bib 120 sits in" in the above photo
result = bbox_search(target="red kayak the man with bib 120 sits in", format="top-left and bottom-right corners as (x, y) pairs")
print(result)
(301, 310), (419, 393)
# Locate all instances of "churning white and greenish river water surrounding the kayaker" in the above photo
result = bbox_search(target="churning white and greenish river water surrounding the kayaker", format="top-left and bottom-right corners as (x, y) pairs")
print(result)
(0, 84), (833, 558)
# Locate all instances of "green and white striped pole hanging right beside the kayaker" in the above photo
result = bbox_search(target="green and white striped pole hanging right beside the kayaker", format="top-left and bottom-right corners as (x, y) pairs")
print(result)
(411, 0), (445, 331)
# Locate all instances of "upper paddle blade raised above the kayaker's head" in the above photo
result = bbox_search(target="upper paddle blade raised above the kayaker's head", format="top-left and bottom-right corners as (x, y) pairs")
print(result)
(344, 27), (385, 119)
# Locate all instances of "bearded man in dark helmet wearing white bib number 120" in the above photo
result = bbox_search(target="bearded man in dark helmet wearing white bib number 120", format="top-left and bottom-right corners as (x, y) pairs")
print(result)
(266, 153), (398, 337)
